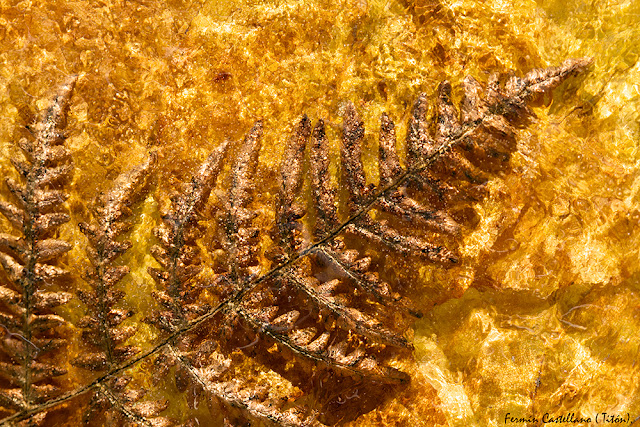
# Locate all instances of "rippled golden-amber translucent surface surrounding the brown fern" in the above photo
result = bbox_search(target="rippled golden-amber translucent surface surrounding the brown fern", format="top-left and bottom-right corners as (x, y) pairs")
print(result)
(0, 0), (640, 426)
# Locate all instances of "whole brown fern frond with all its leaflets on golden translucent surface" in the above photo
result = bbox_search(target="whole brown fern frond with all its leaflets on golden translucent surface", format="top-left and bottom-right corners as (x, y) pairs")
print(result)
(0, 59), (590, 426)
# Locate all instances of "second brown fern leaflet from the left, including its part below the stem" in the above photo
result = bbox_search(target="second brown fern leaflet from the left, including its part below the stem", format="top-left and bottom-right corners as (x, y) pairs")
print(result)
(72, 153), (168, 426)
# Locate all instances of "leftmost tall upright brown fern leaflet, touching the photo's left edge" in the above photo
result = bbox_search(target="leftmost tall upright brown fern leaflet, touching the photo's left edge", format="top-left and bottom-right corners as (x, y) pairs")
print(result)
(0, 76), (76, 424)
